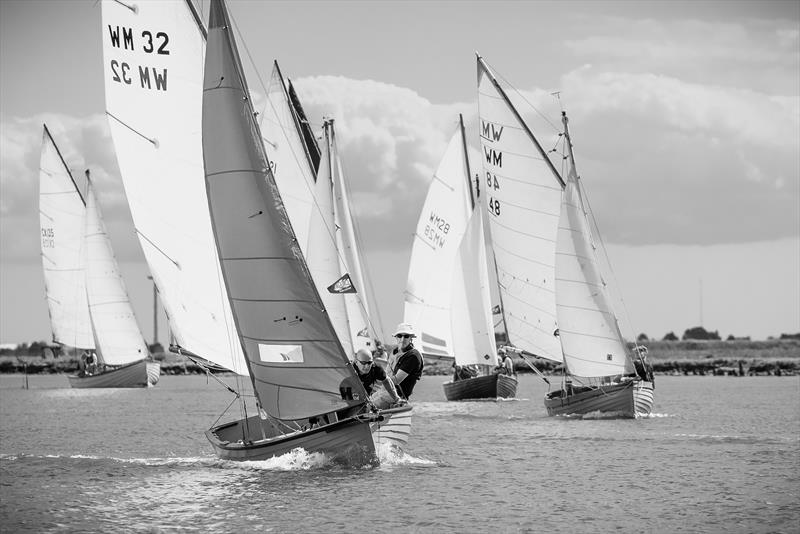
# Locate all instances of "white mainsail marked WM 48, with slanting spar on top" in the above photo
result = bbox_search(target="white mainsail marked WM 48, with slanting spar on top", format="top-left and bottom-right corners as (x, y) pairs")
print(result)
(478, 58), (563, 361)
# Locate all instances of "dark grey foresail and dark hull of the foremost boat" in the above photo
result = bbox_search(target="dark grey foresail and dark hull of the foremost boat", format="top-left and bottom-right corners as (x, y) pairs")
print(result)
(203, 0), (411, 464)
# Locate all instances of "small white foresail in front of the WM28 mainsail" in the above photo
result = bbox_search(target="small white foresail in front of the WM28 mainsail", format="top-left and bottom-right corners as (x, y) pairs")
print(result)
(451, 206), (497, 366)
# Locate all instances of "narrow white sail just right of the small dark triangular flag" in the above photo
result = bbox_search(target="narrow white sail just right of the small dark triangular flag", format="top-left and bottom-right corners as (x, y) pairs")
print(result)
(326, 120), (377, 351)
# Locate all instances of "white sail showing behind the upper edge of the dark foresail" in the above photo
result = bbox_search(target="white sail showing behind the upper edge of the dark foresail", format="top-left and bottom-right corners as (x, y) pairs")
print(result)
(259, 62), (316, 254)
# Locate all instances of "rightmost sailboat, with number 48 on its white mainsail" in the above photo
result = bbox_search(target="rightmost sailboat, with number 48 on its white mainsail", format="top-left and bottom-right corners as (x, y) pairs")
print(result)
(477, 56), (653, 417)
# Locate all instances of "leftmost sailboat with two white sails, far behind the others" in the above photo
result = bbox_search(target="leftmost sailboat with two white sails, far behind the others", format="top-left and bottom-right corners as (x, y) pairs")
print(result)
(39, 125), (160, 388)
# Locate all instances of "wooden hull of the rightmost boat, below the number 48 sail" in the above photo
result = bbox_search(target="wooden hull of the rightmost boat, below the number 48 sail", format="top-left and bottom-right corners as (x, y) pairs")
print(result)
(544, 380), (654, 418)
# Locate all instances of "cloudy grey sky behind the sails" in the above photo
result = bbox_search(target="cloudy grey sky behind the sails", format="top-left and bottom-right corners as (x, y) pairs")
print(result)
(0, 0), (800, 343)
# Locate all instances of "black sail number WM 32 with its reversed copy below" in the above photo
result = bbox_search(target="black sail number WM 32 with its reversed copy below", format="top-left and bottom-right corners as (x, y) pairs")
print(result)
(107, 24), (169, 91)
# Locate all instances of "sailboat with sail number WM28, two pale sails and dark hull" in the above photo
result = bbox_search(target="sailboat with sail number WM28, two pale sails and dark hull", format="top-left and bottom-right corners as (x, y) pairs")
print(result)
(403, 116), (517, 400)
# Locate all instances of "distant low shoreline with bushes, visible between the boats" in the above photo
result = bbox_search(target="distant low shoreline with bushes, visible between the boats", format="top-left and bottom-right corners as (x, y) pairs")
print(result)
(0, 339), (800, 376)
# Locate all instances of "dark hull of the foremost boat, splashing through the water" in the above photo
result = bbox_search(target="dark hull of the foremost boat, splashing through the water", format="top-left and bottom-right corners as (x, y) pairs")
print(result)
(206, 406), (411, 466)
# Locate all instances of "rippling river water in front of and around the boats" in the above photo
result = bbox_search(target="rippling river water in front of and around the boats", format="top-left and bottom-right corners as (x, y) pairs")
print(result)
(0, 375), (800, 533)
